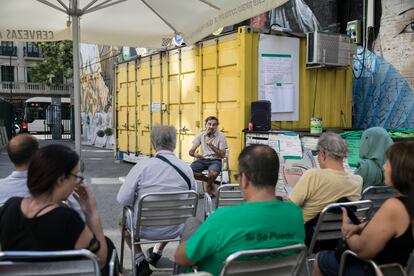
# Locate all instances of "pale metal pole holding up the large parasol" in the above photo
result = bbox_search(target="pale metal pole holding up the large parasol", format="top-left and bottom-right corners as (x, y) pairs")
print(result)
(72, 8), (81, 156)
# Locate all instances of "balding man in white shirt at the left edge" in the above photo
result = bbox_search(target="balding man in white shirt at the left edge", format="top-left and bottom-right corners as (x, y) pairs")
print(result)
(0, 134), (39, 205)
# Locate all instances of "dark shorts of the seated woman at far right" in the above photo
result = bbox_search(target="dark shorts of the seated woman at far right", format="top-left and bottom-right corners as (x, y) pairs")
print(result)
(316, 250), (375, 276)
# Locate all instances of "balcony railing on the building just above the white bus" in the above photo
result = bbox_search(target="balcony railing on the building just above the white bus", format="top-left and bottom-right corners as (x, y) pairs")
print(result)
(0, 81), (71, 96)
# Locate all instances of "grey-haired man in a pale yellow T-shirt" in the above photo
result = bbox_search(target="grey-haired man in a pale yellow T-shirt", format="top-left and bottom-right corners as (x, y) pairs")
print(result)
(289, 132), (362, 223)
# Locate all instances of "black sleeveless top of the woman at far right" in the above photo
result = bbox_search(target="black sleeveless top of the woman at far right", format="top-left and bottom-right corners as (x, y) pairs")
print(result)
(374, 196), (414, 267)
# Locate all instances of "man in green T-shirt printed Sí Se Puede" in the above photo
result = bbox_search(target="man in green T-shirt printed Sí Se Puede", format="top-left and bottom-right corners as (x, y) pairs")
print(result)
(175, 145), (305, 275)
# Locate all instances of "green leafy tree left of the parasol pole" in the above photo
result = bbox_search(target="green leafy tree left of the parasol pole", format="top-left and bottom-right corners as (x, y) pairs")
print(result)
(30, 41), (73, 85)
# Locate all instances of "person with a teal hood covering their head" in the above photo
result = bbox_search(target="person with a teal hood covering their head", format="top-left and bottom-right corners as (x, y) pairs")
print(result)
(355, 127), (393, 190)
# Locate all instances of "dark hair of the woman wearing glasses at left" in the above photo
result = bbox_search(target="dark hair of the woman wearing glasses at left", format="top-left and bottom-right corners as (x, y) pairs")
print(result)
(27, 145), (79, 196)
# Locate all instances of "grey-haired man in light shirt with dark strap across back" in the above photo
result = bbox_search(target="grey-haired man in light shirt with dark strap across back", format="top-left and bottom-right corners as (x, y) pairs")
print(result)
(117, 125), (196, 275)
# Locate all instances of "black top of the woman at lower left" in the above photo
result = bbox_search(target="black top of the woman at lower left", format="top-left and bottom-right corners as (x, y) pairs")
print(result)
(0, 197), (85, 251)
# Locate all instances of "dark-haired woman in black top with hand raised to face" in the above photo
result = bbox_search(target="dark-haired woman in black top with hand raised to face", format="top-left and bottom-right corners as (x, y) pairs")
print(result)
(0, 145), (114, 274)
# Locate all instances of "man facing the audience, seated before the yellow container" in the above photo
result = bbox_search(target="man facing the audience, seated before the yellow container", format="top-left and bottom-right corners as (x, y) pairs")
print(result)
(189, 116), (228, 195)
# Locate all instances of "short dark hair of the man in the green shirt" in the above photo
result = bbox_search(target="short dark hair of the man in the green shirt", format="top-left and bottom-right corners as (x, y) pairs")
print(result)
(238, 145), (279, 188)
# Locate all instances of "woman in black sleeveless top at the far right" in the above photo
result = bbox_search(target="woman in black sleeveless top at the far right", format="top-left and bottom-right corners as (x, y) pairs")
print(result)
(312, 141), (414, 276)
